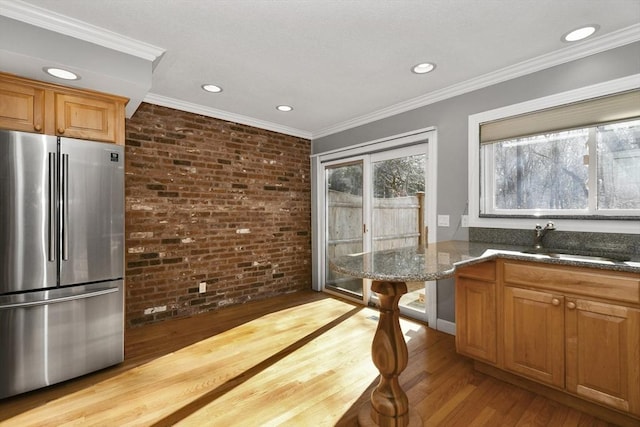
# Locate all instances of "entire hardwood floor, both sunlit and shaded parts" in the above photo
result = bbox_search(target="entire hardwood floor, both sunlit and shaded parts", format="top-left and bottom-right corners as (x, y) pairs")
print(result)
(0, 292), (628, 427)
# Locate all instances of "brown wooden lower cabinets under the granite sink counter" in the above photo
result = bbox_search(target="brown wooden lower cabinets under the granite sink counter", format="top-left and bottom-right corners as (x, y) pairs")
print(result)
(456, 259), (640, 419)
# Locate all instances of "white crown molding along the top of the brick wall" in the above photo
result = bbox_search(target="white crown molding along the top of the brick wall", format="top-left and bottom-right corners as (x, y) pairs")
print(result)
(144, 93), (311, 140)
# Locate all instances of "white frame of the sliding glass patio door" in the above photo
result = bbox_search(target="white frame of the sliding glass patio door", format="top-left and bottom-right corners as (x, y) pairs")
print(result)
(311, 127), (438, 328)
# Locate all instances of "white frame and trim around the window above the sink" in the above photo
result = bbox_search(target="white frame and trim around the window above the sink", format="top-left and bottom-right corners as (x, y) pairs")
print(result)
(468, 74), (640, 234)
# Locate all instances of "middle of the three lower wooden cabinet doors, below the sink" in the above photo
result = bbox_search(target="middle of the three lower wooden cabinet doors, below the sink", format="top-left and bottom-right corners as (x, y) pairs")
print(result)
(504, 286), (565, 388)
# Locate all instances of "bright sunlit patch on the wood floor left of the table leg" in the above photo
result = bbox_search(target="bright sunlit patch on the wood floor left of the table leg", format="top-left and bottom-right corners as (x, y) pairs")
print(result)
(3, 299), (384, 427)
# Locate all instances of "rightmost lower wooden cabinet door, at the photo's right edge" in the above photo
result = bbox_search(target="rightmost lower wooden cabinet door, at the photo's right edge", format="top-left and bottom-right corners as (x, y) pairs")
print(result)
(566, 299), (640, 414)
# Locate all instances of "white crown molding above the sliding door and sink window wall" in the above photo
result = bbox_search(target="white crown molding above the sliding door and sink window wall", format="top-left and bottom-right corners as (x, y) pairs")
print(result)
(312, 24), (640, 139)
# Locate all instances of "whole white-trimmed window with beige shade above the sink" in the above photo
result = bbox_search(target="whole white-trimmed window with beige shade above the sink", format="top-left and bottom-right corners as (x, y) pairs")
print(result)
(469, 75), (640, 234)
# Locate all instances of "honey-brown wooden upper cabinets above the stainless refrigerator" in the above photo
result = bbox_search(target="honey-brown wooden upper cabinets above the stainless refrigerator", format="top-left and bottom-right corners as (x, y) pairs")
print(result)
(0, 73), (127, 145)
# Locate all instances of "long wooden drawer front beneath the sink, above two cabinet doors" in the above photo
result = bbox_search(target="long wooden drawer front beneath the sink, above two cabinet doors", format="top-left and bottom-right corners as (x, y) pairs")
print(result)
(504, 261), (640, 304)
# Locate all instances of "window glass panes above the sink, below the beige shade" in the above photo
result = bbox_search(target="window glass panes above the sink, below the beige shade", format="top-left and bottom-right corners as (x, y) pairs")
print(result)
(480, 120), (640, 218)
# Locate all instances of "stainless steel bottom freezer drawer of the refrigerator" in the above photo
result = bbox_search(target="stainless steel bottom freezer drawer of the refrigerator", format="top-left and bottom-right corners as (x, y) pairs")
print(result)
(0, 280), (124, 398)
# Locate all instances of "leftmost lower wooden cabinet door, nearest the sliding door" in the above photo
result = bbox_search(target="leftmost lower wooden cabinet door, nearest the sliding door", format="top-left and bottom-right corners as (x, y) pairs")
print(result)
(456, 277), (497, 364)
